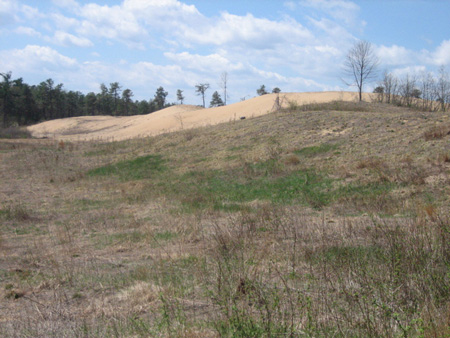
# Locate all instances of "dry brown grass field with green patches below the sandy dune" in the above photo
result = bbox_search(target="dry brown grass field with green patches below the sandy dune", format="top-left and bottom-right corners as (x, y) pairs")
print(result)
(0, 95), (450, 338)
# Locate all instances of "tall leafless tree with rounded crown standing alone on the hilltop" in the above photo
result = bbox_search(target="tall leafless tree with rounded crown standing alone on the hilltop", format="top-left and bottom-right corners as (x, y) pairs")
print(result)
(344, 41), (379, 101)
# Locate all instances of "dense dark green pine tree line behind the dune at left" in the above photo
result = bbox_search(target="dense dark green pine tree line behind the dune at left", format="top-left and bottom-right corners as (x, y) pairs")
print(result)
(0, 72), (179, 127)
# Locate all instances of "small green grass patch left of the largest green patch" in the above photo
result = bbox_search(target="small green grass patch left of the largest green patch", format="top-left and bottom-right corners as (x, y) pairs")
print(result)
(88, 155), (167, 181)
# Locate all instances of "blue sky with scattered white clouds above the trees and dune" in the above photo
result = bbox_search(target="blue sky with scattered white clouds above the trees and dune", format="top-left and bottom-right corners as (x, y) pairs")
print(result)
(0, 0), (450, 104)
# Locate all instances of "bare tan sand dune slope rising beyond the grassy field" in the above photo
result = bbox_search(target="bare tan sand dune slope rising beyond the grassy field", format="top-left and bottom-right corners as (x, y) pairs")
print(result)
(28, 92), (370, 141)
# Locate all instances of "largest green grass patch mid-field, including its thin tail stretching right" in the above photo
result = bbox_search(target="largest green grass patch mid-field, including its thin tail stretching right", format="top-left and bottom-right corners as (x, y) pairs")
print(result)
(171, 163), (397, 212)
